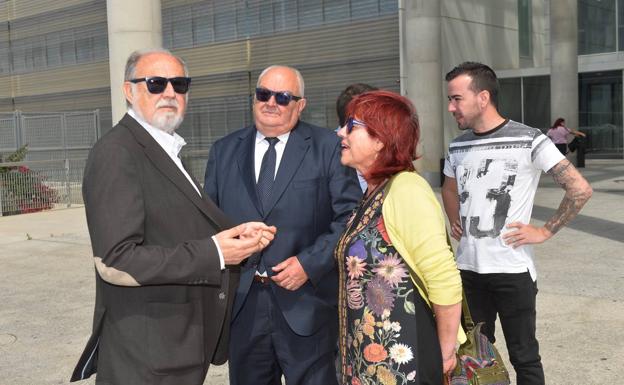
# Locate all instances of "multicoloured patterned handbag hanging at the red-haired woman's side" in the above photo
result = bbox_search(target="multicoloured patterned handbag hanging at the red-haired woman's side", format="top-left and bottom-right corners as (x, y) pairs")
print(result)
(448, 294), (511, 385)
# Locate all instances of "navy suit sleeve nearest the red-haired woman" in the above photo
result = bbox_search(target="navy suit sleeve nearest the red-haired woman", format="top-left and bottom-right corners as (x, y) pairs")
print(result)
(297, 142), (362, 285)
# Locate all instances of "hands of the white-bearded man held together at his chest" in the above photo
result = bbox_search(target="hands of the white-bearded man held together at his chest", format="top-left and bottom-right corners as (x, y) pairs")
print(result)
(215, 222), (277, 265)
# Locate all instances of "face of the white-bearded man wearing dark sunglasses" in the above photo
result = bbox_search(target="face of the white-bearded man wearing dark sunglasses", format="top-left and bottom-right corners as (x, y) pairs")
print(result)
(124, 53), (188, 134)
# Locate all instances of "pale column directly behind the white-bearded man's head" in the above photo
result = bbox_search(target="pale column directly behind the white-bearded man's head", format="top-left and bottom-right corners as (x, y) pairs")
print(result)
(106, 0), (162, 125)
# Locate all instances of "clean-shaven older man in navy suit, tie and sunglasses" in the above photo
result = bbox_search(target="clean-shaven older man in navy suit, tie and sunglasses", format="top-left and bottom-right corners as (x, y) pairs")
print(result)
(204, 66), (362, 385)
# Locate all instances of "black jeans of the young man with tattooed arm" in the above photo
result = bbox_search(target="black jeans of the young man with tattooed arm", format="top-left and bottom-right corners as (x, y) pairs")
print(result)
(461, 270), (544, 385)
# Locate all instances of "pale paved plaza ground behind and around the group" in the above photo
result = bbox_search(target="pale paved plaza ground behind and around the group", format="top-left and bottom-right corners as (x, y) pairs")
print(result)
(0, 160), (624, 385)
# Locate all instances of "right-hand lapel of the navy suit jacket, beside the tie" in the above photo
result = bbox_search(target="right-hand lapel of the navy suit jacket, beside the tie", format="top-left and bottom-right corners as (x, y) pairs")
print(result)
(264, 123), (310, 218)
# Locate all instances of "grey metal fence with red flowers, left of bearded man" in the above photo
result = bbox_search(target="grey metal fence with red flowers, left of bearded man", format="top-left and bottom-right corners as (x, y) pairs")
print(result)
(0, 110), (100, 216)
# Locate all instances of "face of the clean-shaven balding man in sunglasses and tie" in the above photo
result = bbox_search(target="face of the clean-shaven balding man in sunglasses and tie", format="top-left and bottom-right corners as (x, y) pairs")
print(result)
(254, 67), (306, 137)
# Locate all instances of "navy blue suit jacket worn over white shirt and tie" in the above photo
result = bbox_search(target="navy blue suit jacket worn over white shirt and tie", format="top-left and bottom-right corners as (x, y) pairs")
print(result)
(204, 122), (362, 336)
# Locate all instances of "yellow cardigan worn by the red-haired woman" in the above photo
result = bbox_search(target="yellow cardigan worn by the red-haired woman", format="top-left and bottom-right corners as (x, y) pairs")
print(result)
(382, 171), (466, 343)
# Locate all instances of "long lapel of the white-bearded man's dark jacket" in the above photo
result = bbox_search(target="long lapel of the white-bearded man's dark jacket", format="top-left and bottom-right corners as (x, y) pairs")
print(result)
(119, 115), (231, 229)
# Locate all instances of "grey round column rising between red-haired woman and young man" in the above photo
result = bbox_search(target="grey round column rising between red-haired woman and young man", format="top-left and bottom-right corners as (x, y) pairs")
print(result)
(399, 0), (444, 187)
